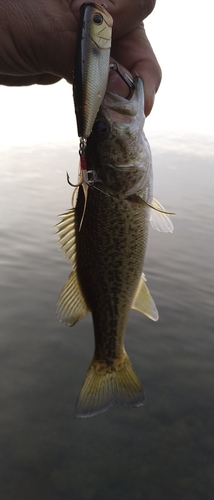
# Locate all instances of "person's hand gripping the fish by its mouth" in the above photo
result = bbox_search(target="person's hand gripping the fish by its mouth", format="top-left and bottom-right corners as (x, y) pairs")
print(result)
(0, 0), (161, 115)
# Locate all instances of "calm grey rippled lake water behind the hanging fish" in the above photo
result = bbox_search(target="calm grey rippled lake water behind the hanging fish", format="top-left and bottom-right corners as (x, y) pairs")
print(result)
(0, 136), (214, 500)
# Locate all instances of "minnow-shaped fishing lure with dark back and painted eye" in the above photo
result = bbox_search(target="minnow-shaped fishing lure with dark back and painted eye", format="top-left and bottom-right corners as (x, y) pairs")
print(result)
(73, 2), (113, 139)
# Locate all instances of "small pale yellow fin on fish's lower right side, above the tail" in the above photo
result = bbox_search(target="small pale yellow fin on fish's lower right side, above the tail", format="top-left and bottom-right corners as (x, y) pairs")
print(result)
(131, 274), (159, 321)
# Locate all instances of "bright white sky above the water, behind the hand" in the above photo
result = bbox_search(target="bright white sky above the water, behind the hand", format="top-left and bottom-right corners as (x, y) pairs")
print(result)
(0, 0), (214, 148)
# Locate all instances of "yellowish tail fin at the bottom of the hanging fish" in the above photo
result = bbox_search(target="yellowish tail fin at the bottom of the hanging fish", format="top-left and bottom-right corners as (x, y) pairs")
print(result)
(76, 353), (145, 418)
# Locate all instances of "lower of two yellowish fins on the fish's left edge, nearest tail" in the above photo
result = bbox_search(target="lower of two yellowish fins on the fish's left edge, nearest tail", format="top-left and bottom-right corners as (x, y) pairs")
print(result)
(56, 267), (89, 326)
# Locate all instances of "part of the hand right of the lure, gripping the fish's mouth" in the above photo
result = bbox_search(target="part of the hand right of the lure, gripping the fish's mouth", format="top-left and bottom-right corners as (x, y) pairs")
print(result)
(106, 0), (161, 116)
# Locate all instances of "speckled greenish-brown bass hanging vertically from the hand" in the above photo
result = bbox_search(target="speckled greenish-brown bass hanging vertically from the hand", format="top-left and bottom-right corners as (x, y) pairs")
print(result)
(57, 77), (171, 417)
